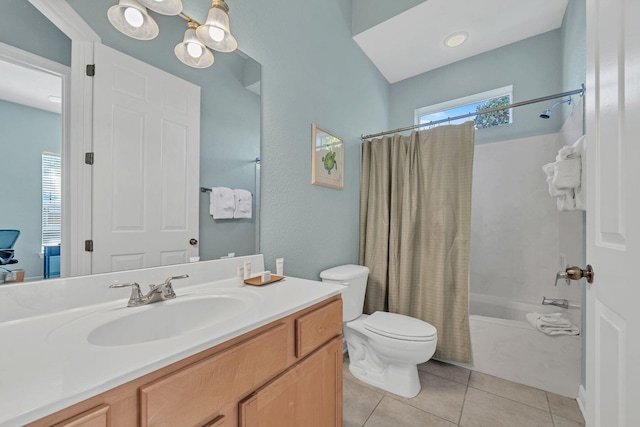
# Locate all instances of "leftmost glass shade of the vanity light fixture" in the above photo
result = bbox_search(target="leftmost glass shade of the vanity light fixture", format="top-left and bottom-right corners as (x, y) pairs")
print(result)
(107, 0), (160, 40)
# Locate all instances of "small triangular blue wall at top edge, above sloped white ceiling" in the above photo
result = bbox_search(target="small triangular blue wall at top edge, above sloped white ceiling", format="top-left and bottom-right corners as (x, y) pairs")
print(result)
(351, 0), (425, 36)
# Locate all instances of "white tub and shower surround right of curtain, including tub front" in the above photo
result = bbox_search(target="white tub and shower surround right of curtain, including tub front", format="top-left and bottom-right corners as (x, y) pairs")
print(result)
(466, 100), (584, 397)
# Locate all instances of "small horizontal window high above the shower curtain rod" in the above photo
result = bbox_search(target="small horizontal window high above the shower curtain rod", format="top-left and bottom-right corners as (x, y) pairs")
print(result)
(414, 86), (513, 129)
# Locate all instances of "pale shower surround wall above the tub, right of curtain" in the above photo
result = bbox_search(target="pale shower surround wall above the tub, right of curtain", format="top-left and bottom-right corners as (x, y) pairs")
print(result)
(470, 101), (584, 312)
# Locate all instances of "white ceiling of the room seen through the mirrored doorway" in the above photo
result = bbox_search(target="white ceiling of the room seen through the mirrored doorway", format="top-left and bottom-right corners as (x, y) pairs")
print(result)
(0, 61), (62, 114)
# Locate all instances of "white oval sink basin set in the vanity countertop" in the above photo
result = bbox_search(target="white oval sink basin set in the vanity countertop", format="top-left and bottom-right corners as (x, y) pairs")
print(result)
(47, 290), (261, 346)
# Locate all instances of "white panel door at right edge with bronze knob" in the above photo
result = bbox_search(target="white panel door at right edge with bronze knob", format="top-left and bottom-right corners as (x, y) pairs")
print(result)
(585, 0), (640, 427)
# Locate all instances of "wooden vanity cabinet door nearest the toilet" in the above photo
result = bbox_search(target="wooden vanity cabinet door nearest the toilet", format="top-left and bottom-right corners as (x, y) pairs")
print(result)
(239, 337), (342, 427)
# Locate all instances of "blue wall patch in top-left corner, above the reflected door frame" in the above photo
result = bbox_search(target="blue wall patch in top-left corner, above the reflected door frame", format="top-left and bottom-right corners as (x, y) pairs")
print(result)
(0, 0), (71, 66)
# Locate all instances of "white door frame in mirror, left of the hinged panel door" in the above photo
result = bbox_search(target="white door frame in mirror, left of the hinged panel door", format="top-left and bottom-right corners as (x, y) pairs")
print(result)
(29, 0), (101, 277)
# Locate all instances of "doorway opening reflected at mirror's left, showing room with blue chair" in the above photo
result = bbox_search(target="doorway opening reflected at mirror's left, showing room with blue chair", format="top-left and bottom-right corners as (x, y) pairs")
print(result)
(0, 44), (69, 281)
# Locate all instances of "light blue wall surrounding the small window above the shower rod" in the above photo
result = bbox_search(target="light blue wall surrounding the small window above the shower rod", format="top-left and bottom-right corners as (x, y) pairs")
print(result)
(390, 30), (564, 144)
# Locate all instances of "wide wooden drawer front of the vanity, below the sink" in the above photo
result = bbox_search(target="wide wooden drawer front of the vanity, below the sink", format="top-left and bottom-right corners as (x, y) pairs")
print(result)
(140, 324), (287, 426)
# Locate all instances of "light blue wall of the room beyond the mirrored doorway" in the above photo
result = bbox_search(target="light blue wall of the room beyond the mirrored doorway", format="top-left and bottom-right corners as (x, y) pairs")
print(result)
(0, 101), (62, 277)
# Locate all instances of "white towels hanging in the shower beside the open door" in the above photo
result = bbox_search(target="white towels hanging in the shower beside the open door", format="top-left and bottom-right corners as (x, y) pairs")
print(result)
(542, 135), (586, 211)
